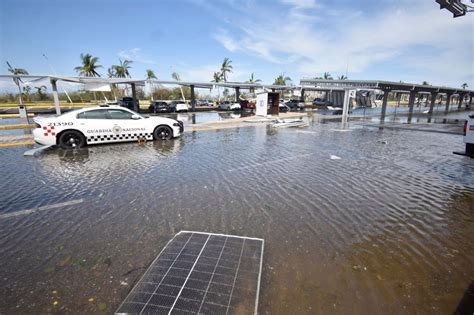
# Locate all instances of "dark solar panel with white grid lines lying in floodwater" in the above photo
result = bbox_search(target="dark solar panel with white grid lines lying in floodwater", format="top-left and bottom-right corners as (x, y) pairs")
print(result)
(116, 231), (264, 314)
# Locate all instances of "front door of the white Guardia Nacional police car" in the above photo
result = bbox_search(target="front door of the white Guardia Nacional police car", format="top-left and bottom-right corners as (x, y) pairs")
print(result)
(107, 108), (148, 141)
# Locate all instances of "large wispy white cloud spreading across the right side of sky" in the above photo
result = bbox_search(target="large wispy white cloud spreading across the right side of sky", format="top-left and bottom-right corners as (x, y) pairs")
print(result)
(214, 0), (474, 85)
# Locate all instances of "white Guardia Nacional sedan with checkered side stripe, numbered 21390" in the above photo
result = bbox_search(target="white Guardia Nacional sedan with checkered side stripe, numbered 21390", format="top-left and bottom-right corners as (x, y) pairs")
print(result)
(33, 105), (184, 148)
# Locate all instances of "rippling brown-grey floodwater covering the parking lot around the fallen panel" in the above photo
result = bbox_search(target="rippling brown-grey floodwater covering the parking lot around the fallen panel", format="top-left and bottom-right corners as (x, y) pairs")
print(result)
(0, 117), (474, 314)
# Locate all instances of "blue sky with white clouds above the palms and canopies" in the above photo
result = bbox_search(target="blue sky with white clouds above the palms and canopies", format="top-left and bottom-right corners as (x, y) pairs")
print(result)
(0, 0), (474, 91)
